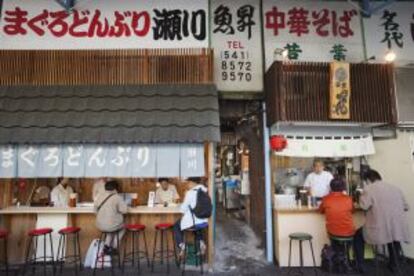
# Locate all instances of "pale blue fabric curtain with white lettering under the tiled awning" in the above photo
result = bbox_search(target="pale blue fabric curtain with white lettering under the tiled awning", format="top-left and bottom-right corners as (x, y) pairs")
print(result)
(0, 144), (204, 178)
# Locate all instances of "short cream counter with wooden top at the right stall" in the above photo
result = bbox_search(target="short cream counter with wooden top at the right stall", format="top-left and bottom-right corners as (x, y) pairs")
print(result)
(273, 207), (365, 267)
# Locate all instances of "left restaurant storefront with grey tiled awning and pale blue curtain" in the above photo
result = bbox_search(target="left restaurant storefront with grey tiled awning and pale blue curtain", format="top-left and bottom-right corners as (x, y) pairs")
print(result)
(0, 49), (220, 264)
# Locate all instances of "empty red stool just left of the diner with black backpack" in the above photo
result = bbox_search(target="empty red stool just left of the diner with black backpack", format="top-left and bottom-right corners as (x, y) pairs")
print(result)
(151, 223), (178, 273)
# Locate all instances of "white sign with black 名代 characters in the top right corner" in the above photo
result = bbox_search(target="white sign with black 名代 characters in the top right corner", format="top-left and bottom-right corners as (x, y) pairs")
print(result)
(363, 2), (414, 65)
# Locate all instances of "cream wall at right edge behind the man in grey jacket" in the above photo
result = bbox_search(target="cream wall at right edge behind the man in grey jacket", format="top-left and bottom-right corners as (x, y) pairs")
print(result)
(368, 131), (414, 258)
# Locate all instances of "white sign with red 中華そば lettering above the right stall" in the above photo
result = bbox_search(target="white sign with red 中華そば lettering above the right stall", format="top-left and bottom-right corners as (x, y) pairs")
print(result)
(263, 0), (364, 68)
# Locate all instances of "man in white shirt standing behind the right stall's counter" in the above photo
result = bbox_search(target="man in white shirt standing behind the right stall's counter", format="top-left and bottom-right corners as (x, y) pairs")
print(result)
(303, 159), (333, 199)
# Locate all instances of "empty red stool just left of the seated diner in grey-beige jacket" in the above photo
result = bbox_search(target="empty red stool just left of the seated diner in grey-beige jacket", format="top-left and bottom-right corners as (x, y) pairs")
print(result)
(56, 227), (82, 275)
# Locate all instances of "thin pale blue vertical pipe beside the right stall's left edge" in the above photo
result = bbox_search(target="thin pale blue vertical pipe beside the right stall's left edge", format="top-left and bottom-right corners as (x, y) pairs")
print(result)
(262, 102), (273, 263)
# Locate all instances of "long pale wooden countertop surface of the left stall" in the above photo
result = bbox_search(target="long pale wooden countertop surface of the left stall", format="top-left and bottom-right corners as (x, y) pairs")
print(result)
(0, 205), (180, 215)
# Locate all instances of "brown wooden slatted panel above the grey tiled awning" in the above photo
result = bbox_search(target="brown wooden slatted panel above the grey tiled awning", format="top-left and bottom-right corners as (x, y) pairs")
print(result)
(0, 49), (214, 86)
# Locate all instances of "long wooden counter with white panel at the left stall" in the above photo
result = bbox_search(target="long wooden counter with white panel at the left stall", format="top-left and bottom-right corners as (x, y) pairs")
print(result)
(0, 205), (188, 263)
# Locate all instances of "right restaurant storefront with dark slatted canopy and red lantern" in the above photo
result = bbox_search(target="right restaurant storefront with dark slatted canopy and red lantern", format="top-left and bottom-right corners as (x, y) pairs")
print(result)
(266, 62), (396, 266)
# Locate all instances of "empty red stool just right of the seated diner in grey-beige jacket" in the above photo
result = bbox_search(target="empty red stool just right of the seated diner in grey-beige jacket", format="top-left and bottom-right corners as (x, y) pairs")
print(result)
(122, 224), (150, 272)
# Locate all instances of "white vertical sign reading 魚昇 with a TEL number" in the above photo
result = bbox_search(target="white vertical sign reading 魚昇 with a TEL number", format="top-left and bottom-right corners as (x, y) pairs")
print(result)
(210, 0), (263, 91)
